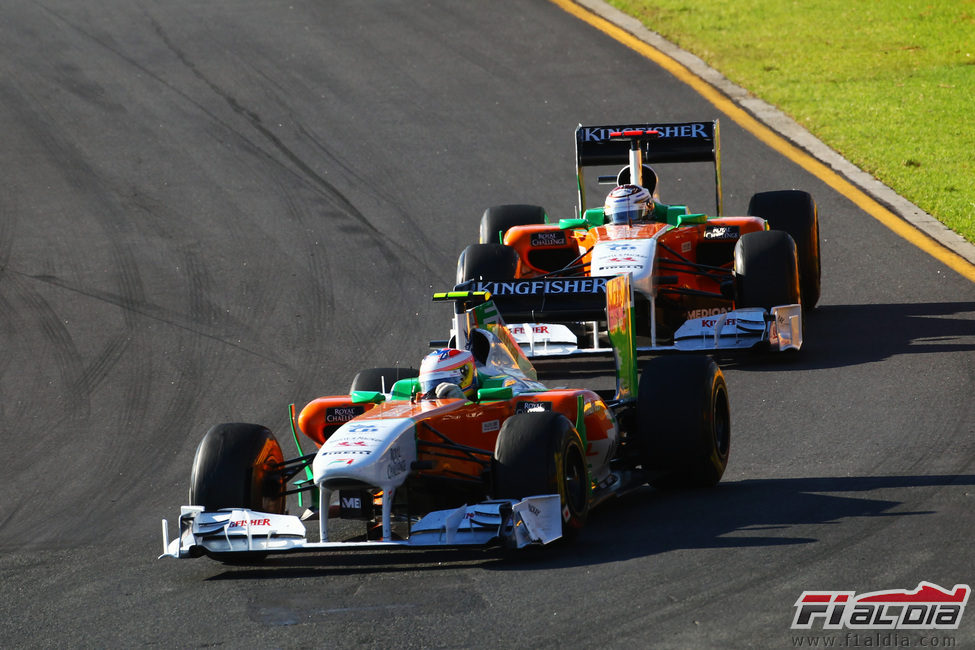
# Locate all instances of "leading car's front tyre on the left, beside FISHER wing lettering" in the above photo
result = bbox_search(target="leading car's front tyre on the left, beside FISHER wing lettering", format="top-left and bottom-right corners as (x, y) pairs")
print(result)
(189, 423), (286, 514)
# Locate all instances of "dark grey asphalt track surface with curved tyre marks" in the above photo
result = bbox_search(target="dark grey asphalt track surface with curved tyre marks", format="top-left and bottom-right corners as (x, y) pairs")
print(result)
(0, 0), (975, 648)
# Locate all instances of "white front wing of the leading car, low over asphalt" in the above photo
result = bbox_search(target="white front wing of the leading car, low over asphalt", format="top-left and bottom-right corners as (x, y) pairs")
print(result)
(159, 494), (562, 558)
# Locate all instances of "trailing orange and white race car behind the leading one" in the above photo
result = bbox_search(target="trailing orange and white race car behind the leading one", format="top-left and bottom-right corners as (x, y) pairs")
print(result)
(457, 120), (820, 356)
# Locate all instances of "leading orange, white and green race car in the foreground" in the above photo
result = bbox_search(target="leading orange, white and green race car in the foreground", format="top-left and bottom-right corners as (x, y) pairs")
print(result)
(160, 286), (730, 562)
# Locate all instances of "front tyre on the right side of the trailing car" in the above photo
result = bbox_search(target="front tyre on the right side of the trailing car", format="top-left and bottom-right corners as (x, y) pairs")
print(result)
(735, 230), (800, 309)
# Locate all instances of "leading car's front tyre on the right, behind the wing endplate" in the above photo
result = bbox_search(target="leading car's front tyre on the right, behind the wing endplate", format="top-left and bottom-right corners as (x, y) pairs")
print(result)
(493, 411), (590, 537)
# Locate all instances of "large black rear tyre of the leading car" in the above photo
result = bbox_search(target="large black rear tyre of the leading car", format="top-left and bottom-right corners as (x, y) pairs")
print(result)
(636, 356), (731, 488)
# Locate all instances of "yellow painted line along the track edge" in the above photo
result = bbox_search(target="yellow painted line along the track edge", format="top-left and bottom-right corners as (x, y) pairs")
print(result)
(549, 0), (975, 282)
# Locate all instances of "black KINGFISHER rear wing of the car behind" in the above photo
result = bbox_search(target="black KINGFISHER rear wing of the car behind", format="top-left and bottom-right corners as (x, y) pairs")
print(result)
(576, 120), (722, 217)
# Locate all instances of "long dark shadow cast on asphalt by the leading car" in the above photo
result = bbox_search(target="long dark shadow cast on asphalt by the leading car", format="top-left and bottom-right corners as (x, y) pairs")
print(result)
(202, 474), (975, 580)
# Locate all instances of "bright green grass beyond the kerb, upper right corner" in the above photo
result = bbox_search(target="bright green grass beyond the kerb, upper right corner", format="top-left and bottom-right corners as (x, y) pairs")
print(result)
(608, 0), (975, 242)
